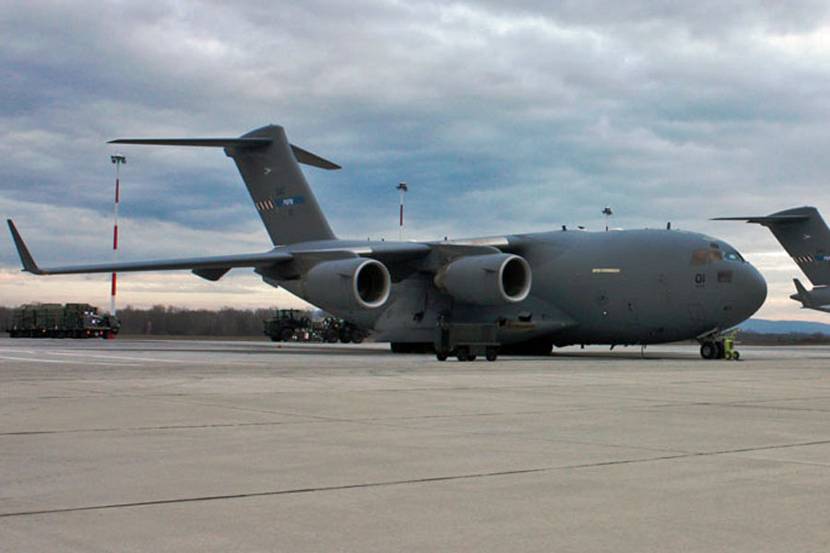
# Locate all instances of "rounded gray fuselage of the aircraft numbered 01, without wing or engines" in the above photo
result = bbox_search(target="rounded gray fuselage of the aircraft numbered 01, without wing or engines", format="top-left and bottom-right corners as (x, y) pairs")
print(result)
(272, 229), (767, 346)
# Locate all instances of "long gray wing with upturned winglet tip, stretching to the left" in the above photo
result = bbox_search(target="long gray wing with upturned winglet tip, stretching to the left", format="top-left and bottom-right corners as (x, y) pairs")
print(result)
(8, 219), (294, 280)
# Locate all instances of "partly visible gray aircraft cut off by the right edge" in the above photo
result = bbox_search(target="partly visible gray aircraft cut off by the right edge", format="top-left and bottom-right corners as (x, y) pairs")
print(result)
(715, 206), (830, 313)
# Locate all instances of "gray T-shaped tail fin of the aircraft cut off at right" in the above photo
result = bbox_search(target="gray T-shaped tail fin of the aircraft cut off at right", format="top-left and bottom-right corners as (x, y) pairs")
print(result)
(715, 206), (830, 285)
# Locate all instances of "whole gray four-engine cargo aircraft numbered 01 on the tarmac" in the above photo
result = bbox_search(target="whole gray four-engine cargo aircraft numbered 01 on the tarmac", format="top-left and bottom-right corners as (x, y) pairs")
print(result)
(9, 125), (767, 358)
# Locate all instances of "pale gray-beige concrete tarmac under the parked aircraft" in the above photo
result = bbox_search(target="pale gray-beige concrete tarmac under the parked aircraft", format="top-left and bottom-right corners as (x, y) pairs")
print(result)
(0, 339), (830, 552)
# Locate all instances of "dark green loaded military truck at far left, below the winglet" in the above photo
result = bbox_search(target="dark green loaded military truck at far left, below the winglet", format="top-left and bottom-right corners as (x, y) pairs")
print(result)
(6, 303), (121, 338)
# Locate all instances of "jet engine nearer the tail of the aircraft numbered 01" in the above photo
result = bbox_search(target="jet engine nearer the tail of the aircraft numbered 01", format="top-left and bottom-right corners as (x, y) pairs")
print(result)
(303, 257), (392, 309)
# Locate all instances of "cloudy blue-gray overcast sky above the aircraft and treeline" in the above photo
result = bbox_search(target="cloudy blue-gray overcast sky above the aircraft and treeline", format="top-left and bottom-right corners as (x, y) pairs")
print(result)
(0, 0), (830, 316)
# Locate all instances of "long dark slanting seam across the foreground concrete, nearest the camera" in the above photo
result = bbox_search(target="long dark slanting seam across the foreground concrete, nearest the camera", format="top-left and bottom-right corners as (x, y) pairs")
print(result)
(0, 440), (830, 518)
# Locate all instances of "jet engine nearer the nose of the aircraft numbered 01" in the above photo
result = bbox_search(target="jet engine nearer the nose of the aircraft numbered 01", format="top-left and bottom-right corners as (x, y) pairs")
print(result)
(434, 253), (532, 305)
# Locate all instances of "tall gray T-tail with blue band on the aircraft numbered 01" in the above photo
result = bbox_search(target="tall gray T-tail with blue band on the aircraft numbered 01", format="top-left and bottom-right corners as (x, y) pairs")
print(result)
(111, 125), (340, 245)
